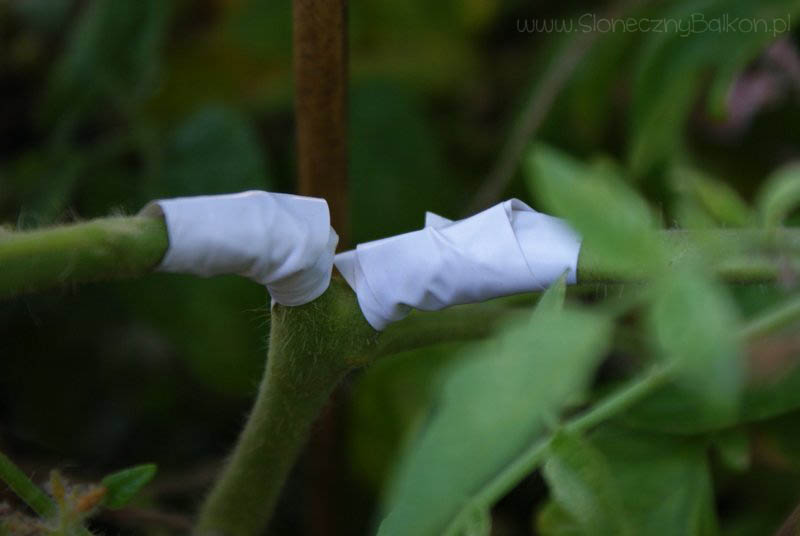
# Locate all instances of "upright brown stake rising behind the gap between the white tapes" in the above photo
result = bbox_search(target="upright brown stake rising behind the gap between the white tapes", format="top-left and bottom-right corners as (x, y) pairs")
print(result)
(292, 0), (350, 245)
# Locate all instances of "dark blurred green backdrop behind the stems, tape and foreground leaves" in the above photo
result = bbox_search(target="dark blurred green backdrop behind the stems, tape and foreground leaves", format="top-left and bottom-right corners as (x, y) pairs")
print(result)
(0, 0), (800, 534)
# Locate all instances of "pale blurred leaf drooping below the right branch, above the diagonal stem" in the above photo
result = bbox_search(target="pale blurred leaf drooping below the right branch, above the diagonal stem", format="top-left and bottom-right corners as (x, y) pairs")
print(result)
(627, 269), (745, 432)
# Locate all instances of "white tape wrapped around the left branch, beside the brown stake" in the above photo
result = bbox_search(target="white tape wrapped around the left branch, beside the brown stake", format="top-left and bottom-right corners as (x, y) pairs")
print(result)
(141, 191), (339, 305)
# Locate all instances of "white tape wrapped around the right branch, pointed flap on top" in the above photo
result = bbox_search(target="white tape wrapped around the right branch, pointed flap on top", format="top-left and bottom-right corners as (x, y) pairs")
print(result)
(335, 199), (581, 331)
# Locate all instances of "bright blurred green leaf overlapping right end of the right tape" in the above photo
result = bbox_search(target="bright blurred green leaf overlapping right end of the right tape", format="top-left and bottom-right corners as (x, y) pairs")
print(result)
(527, 145), (663, 275)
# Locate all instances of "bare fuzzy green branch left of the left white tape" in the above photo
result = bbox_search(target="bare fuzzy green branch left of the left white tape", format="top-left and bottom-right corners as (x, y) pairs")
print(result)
(0, 217), (167, 298)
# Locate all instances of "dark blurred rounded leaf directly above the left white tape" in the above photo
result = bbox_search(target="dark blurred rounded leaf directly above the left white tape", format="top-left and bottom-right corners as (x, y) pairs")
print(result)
(152, 106), (274, 198)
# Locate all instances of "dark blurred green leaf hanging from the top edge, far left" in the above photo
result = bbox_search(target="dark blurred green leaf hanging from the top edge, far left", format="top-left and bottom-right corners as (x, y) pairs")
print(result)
(46, 0), (172, 119)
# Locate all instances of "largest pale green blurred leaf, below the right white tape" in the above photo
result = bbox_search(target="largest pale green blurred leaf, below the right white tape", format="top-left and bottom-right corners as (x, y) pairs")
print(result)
(380, 310), (610, 536)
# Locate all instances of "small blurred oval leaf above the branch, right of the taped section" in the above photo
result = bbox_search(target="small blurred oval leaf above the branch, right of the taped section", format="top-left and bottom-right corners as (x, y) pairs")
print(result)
(672, 167), (752, 227)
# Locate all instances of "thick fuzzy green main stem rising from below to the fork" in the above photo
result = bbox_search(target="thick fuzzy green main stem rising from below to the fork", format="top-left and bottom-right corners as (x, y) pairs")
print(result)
(195, 279), (377, 536)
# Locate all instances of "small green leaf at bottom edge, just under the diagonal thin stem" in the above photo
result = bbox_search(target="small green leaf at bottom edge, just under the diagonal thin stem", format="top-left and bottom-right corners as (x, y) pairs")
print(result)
(544, 431), (634, 536)
